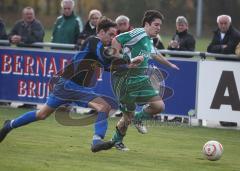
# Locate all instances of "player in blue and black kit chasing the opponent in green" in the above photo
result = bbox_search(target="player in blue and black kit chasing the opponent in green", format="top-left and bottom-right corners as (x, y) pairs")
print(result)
(0, 17), (142, 152)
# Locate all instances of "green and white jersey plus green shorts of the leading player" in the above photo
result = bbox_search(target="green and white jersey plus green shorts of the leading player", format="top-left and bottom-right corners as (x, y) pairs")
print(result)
(112, 28), (158, 104)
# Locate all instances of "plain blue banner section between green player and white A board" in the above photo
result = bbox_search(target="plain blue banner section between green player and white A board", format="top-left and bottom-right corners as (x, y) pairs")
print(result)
(151, 59), (198, 115)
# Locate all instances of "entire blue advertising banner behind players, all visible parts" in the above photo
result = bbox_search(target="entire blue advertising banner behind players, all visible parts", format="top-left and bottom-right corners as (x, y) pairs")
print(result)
(0, 47), (197, 115)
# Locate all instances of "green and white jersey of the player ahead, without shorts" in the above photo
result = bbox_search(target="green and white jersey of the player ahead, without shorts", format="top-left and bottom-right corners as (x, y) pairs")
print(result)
(116, 28), (154, 67)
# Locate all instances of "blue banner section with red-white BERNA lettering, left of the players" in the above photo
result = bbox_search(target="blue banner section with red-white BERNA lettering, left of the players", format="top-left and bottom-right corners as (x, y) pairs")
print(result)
(0, 48), (73, 103)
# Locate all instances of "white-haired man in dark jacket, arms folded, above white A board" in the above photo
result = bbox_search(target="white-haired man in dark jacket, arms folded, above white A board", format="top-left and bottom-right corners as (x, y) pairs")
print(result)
(207, 15), (240, 54)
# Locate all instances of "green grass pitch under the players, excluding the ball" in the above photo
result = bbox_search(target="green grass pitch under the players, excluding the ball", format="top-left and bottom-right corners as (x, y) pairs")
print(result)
(0, 108), (240, 171)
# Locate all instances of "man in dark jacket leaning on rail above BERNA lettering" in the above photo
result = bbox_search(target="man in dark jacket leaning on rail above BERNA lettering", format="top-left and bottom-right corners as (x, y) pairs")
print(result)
(9, 7), (44, 46)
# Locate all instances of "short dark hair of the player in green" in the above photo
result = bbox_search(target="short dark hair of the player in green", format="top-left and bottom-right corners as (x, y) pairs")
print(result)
(142, 10), (164, 27)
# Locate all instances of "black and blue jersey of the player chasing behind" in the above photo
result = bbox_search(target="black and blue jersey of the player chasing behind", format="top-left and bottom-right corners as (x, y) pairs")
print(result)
(67, 36), (111, 87)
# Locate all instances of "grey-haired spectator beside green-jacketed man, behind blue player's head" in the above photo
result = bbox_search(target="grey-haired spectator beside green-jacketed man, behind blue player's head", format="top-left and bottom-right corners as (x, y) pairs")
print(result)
(78, 9), (102, 45)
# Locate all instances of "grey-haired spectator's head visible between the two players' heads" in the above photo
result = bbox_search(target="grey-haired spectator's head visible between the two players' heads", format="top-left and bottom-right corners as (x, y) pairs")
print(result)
(115, 15), (133, 34)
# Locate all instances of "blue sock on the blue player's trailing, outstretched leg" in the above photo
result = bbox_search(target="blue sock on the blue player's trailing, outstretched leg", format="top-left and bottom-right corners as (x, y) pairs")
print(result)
(10, 111), (37, 128)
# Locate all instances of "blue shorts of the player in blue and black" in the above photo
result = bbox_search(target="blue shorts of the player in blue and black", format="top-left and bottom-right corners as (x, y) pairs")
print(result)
(46, 78), (98, 108)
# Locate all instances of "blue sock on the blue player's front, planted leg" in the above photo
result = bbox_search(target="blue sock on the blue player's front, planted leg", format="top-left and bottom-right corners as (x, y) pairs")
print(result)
(93, 112), (108, 140)
